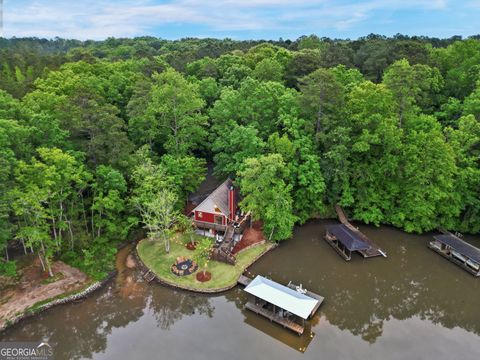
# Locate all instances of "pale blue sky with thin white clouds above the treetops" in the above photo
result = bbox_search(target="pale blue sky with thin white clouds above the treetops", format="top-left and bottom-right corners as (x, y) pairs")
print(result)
(0, 0), (480, 40)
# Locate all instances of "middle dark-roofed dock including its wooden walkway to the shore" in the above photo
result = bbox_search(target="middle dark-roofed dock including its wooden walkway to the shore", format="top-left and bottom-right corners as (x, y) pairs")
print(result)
(325, 204), (387, 261)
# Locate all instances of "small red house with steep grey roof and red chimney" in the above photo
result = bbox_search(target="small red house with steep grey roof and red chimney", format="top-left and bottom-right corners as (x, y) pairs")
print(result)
(192, 179), (238, 231)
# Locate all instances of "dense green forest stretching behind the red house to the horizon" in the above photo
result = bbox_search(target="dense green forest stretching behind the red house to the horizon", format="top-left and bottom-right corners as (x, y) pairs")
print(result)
(0, 35), (480, 278)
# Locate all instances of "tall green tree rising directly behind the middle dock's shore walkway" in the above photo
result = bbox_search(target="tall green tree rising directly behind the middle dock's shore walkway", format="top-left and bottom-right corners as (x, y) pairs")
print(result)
(342, 81), (402, 225)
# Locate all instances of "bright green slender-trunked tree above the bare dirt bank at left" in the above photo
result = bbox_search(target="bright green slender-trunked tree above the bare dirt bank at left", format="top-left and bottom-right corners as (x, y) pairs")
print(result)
(11, 148), (89, 276)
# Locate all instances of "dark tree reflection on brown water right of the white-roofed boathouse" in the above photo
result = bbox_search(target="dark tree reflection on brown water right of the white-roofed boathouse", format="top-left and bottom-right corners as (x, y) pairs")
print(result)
(251, 222), (480, 343)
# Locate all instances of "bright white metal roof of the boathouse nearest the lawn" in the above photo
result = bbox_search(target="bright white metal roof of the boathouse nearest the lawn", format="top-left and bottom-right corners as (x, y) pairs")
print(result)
(245, 275), (318, 319)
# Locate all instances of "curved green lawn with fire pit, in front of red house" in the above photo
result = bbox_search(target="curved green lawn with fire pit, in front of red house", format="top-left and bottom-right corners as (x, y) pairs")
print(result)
(137, 235), (272, 291)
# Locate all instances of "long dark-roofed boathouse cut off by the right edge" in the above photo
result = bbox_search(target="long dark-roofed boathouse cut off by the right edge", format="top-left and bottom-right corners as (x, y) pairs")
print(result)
(428, 233), (480, 276)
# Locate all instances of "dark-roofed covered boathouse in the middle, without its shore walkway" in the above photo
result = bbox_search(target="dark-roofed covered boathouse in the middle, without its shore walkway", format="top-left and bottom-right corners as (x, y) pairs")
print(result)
(325, 224), (370, 261)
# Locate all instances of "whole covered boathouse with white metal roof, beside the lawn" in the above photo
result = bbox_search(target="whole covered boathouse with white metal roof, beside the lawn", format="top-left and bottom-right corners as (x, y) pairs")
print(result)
(244, 275), (323, 335)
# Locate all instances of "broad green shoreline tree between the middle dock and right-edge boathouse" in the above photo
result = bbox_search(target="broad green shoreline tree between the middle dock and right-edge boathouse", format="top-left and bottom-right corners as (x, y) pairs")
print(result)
(391, 115), (461, 232)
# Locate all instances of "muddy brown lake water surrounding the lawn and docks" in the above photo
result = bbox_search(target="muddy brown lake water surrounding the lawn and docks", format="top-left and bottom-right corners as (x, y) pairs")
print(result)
(0, 221), (480, 360)
